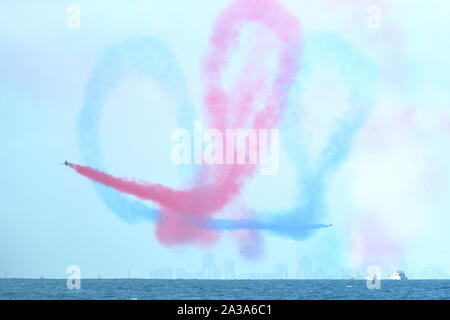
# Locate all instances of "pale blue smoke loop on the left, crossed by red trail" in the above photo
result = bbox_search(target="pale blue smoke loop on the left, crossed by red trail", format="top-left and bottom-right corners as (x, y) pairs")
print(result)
(79, 37), (193, 223)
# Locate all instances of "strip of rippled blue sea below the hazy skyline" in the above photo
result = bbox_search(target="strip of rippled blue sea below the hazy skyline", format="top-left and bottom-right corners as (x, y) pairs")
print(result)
(0, 278), (450, 300)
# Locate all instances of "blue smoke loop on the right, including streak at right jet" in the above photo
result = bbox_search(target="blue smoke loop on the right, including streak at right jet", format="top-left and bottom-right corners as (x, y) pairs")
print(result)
(209, 32), (377, 240)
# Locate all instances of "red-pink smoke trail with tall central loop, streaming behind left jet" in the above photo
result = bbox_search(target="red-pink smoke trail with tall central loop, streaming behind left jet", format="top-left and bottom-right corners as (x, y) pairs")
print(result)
(71, 0), (300, 245)
